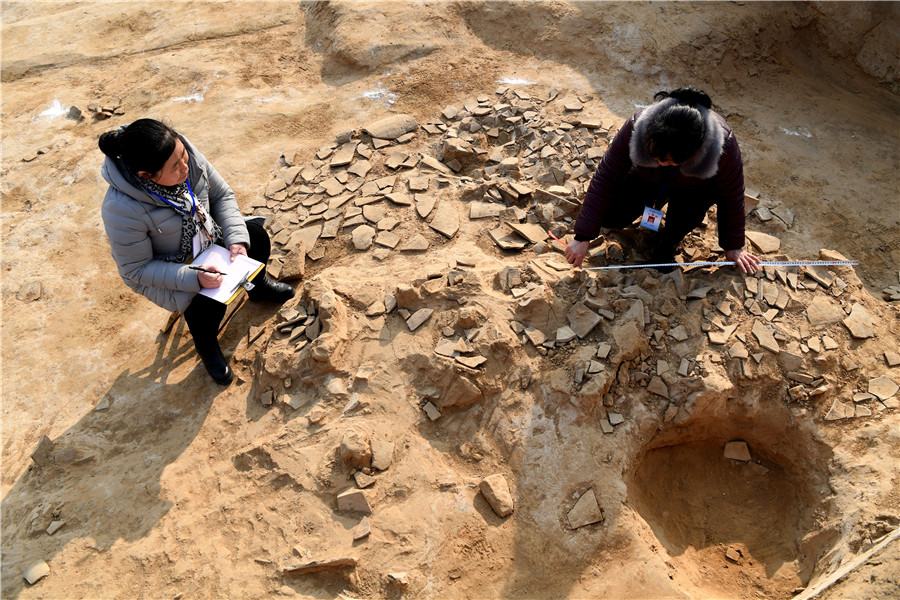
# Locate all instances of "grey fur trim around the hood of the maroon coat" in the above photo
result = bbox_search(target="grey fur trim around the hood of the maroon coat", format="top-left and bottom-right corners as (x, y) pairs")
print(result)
(628, 98), (730, 179)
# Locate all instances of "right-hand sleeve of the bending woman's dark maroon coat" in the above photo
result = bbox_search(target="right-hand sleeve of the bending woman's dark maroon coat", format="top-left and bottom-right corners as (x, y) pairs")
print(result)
(715, 132), (746, 250)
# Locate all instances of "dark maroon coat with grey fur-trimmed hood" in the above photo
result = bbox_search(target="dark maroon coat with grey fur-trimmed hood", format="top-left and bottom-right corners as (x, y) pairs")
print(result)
(575, 98), (745, 250)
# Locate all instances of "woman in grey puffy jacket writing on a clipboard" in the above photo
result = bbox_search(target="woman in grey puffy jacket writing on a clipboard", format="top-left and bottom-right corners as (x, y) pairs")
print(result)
(99, 119), (294, 385)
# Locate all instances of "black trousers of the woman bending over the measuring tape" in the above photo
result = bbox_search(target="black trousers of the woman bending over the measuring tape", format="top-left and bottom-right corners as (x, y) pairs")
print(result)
(603, 174), (717, 250)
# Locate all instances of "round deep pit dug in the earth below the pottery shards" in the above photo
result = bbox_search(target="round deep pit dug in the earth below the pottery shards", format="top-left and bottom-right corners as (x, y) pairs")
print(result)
(628, 400), (835, 598)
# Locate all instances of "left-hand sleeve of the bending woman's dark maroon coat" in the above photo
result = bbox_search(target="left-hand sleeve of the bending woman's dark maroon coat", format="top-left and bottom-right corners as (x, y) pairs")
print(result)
(575, 116), (635, 241)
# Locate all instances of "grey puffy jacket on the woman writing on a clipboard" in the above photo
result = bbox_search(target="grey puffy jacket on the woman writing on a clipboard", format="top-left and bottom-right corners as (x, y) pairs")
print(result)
(101, 137), (250, 313)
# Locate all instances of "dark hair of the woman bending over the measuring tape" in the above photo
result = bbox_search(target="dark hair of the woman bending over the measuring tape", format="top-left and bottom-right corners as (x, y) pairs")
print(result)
(646, 87), (712, 164)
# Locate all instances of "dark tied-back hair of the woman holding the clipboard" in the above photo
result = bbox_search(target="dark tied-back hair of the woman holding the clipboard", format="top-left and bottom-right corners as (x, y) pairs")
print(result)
(98, 119), (178, 174)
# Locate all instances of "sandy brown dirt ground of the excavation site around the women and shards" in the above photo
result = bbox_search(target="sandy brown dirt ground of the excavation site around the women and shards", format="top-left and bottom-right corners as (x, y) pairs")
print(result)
(0, 1), (900, 599)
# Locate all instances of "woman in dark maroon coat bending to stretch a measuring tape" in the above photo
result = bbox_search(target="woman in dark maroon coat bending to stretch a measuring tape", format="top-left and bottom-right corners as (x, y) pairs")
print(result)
(566, 88), (760, 273)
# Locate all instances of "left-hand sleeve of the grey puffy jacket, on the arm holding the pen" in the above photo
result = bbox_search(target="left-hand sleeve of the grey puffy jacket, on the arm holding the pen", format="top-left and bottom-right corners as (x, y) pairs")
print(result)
(102, 188), (200, 295)
